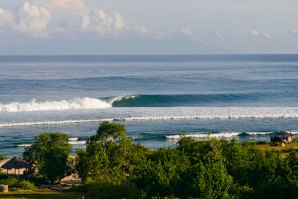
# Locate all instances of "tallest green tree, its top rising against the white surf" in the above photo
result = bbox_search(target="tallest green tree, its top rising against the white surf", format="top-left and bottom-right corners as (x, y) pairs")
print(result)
(76, 122), (149, 185)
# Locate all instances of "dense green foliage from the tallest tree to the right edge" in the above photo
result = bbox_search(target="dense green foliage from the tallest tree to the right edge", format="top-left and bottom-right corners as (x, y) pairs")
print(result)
(76, 122), (298, 198)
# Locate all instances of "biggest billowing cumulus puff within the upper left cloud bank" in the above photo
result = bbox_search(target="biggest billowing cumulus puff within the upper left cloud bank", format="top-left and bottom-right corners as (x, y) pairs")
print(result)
(15, 2), (52, 37)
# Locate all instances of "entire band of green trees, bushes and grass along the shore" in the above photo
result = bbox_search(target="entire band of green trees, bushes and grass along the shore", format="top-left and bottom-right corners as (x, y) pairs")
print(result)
(0, 122), (298, 199)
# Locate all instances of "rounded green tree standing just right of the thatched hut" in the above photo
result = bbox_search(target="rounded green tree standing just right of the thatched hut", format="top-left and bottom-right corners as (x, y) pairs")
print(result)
(23, 132), (71, 183)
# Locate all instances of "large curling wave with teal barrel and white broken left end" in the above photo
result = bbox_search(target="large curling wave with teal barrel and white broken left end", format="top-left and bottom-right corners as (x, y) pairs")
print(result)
(0, 93), (296, 112)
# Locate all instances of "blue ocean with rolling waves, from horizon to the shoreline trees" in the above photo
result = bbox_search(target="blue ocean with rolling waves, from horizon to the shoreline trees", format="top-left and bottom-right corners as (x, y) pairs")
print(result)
(0, 55), (298, 157)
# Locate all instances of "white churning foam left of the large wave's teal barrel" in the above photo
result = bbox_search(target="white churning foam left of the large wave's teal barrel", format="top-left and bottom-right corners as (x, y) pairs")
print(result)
(0, 97), (112, 112)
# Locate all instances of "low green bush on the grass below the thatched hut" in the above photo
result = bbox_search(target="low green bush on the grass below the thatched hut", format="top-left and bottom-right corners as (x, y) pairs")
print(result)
(0, 177), (36, 190)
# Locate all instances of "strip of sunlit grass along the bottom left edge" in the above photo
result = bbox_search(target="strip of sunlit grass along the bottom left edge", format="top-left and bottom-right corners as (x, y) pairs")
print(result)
(0, 189), (82, 199)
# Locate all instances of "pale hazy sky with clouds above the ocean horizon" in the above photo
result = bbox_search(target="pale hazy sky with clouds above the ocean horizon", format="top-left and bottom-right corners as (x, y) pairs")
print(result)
(0, 0), (298, 55)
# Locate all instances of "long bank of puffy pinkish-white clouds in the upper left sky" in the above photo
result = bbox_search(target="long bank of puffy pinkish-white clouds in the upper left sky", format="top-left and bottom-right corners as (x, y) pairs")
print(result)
(0, 0), (126, 38)
